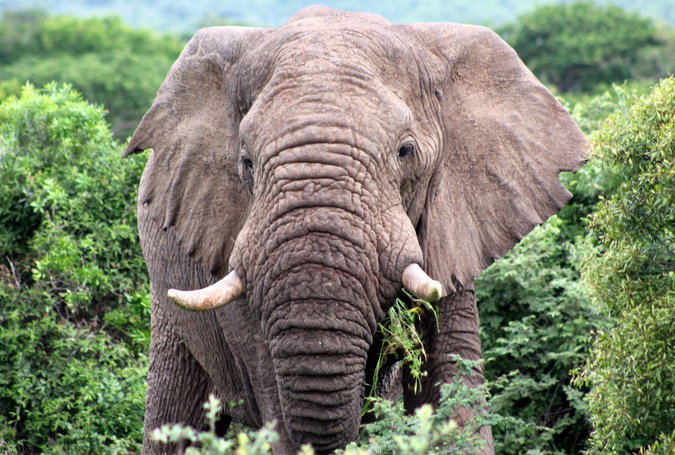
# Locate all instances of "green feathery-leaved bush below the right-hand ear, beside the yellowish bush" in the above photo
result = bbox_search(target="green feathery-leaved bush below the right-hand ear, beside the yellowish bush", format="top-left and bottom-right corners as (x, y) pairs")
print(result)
(476, 213), (604, 454)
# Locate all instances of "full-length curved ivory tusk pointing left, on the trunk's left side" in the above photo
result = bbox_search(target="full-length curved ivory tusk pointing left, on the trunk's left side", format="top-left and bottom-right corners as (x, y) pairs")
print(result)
(167, 270), (244, 311)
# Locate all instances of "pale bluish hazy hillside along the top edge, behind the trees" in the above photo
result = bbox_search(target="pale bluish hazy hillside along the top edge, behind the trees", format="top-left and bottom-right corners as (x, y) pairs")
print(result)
(0, 0), (675, 33)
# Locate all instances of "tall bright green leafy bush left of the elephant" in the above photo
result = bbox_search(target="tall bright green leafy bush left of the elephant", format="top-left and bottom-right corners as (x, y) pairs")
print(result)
(0, 85), (149, 454)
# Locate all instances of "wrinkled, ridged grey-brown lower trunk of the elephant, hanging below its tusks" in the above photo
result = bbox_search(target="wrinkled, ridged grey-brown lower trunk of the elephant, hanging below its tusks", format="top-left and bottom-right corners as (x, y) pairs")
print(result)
(263, 247), (375, 453)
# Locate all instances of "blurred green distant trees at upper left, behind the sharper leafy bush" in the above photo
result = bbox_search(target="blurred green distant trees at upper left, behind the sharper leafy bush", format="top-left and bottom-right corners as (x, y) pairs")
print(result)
(0, 11), (183, 137)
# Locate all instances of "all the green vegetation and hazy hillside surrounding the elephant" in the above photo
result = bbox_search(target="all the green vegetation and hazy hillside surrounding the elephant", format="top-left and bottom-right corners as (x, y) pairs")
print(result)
(0, 0), (675, 454)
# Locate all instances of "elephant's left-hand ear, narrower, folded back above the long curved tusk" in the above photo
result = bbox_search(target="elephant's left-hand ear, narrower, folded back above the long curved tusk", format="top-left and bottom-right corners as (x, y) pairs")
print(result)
(124, 27), (260, 282)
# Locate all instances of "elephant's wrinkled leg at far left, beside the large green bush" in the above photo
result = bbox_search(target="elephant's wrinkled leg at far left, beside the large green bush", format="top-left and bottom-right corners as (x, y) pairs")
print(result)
(142, 315), (217, 455)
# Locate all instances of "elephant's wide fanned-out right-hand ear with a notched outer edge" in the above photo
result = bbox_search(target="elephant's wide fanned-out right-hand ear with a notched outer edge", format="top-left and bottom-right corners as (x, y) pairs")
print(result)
(411, 23), (587, 292)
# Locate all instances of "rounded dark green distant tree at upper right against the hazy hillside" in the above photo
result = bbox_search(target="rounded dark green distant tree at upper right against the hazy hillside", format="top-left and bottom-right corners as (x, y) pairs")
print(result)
(501, 1), (658, 92)
